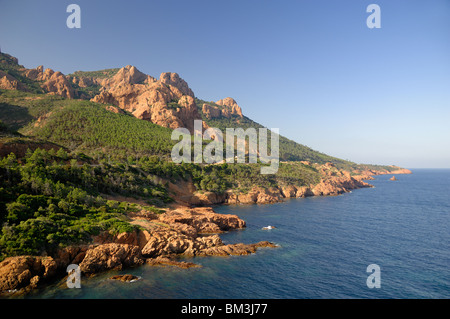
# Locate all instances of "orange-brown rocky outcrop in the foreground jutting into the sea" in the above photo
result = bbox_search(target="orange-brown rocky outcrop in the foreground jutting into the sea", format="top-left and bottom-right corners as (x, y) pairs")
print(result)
(0, 206), (276, 296)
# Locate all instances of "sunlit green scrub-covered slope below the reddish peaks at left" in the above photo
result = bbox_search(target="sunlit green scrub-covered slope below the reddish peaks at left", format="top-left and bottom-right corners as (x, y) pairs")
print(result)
(0, 90), (174, 158)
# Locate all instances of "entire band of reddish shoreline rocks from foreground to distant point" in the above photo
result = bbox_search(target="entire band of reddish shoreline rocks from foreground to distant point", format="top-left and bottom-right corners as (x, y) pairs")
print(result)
(0, 168), (412, 297)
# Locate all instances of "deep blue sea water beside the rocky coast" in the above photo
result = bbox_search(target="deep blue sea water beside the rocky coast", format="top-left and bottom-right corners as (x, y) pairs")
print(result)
(26, 169), (450, 299)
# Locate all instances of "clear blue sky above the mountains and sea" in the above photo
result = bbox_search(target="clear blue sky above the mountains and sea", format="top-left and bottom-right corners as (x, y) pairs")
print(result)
(0, 0), (450, 168)
